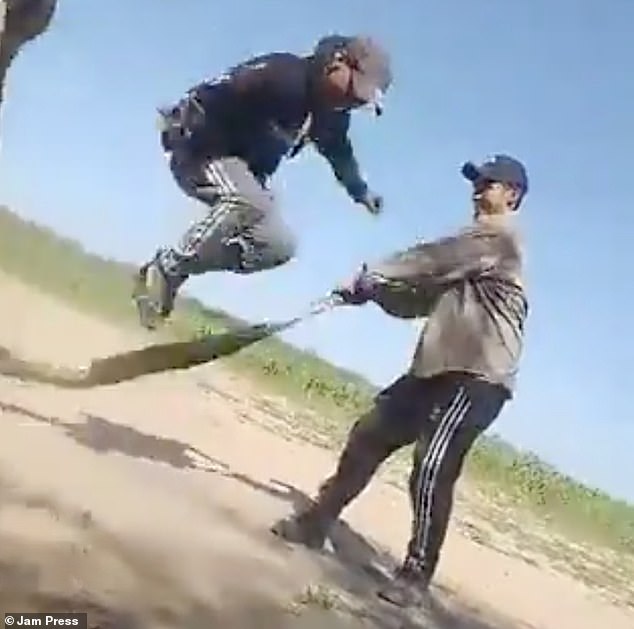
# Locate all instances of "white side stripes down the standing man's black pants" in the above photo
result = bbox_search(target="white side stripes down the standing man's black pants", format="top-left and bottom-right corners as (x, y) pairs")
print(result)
(413, 387), (471, 552)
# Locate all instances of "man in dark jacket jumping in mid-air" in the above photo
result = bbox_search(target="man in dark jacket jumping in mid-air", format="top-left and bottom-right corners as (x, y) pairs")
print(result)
(134, 35), (392, 329)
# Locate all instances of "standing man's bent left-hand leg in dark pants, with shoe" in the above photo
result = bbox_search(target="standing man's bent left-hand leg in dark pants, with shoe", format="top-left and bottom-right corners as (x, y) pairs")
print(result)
(271, 376), (427, 548)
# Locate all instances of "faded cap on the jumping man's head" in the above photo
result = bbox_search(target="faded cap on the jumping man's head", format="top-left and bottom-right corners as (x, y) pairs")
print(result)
(315, 35), (392, 114)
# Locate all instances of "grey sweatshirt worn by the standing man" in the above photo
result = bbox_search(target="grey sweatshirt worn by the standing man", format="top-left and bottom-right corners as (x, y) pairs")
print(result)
(368, 216), (528, 396)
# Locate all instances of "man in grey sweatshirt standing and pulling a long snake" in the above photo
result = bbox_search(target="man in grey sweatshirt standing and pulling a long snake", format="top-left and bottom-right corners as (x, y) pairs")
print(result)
(272, 155), (528, 607)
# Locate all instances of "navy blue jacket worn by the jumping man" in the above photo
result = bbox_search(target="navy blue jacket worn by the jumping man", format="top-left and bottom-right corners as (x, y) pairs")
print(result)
(162, 53), (368, 201)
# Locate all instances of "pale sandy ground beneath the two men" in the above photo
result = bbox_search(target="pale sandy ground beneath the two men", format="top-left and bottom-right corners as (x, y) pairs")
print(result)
(0, 276), (634, 629)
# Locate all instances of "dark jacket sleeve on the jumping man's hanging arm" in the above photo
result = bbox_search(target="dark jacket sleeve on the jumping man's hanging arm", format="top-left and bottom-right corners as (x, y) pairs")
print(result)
(311, 112), (368, 201)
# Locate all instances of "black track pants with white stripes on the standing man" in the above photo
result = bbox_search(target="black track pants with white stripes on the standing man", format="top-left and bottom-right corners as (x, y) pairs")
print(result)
(308, 374), (508, 578)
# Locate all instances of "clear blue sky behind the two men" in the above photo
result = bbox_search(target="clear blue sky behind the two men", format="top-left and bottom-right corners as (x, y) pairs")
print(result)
(0, 0), (634, 500)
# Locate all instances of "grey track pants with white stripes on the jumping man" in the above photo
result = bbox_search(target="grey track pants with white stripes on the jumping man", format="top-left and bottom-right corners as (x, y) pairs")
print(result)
(155, 153), (295, 288)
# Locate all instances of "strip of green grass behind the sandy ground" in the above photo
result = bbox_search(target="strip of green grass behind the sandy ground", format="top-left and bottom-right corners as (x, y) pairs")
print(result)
(0, 208), (634, 555)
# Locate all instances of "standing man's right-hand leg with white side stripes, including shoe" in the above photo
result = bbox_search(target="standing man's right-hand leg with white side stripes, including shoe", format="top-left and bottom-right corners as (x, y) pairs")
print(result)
(379, 375), (508, 607)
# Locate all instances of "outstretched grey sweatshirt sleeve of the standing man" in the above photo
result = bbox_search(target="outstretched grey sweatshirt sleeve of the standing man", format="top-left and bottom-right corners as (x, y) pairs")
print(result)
(367, 230), (510, 319)
